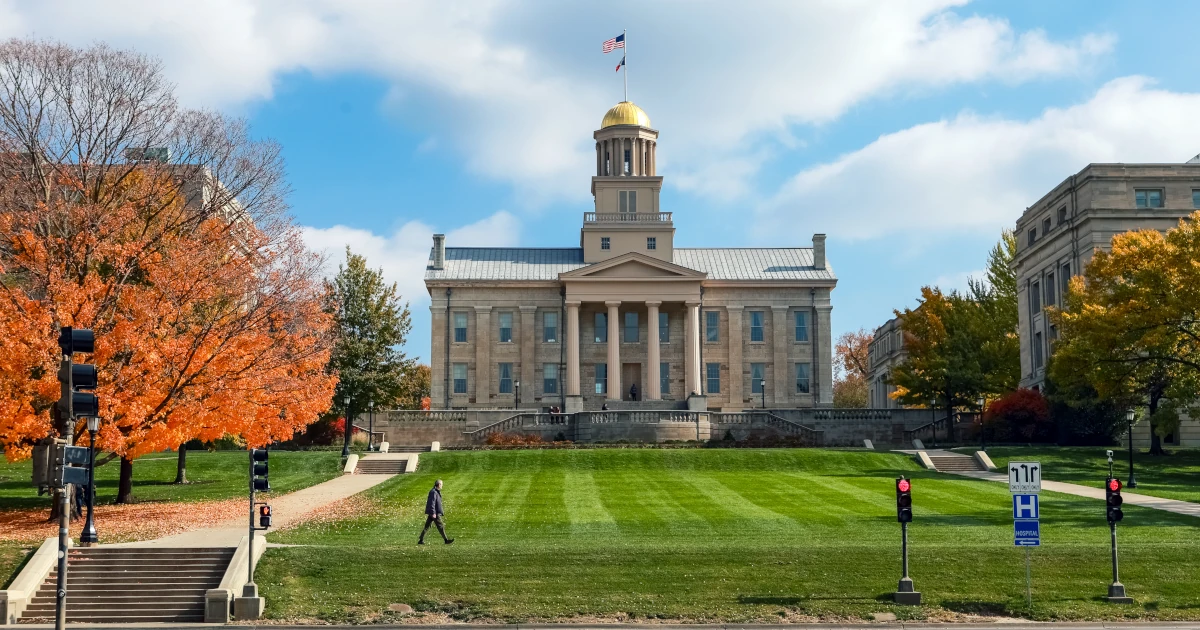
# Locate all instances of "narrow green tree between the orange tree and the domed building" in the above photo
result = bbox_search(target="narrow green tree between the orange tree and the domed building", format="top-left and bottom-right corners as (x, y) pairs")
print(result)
(325, 247), (416, 418)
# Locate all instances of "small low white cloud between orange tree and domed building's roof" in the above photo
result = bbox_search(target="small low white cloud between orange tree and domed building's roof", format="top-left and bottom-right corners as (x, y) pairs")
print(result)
(304, 210), (521, 309)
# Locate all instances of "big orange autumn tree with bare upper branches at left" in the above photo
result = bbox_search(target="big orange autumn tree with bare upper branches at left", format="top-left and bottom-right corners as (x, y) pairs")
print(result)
(0, 41), (336, 502)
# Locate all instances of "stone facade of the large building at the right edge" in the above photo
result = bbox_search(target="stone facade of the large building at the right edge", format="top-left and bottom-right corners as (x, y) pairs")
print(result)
(1014, 162), (1200, 446)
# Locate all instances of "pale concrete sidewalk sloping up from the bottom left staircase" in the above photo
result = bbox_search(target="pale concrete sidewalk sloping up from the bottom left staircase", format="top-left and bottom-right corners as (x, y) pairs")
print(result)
(111, 465), (396, 547)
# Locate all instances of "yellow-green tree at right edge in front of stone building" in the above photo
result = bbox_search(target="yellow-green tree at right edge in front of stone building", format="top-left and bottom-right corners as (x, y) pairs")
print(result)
(1049, 212), (1200, 455)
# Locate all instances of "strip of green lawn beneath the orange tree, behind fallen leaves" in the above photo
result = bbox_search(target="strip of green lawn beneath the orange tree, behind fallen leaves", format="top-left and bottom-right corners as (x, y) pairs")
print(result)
(0, 451), (341, 509)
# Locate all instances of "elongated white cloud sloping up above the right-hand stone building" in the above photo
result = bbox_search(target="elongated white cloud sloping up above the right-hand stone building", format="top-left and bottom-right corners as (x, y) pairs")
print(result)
(755, 77), (1200, 240)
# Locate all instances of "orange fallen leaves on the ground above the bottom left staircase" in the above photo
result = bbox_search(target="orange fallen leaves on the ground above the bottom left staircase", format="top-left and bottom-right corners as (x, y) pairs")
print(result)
(0, 499), (247, 542)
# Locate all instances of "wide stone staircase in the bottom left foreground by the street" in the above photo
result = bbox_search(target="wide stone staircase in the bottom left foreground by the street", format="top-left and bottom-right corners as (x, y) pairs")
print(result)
(20, 547), (234, 623)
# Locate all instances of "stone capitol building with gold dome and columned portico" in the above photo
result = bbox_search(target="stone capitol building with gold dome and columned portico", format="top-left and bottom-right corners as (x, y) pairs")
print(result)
(425, 101), (838, 413)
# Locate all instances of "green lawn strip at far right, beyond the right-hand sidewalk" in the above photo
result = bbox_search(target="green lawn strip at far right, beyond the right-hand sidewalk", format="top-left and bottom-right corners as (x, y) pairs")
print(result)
(972, 446), (1200, 502)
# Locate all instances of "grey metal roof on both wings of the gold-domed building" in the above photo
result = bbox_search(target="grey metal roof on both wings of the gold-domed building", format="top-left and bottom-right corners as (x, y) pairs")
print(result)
(425, 247), (836, 281)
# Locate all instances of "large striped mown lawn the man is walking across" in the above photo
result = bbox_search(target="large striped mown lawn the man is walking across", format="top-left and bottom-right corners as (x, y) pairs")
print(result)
(256, 449), (1200, 622)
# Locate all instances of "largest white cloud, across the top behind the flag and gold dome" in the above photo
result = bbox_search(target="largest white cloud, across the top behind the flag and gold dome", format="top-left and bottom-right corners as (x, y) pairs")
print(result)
(0, 0), (1114, 203)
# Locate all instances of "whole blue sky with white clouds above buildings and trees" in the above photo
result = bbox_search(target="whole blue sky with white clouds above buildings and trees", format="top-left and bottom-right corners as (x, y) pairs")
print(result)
(0, 0), (1200, 358)
